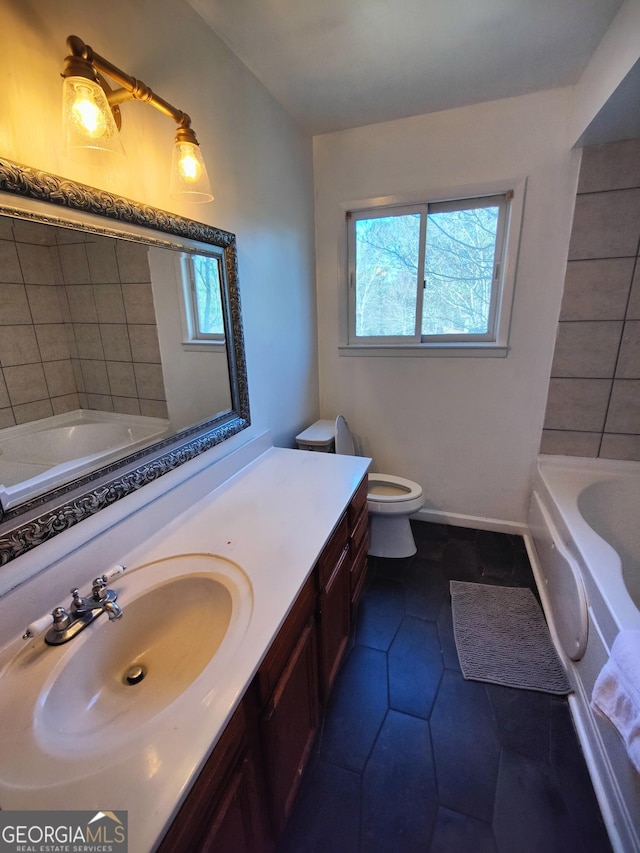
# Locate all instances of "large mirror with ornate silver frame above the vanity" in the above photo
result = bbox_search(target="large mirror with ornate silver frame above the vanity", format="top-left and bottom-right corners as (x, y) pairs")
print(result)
(0, 161), (249, 564)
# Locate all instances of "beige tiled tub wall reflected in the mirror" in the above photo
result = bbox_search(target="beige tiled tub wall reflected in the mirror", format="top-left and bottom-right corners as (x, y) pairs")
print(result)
(0, 217), (167, 428)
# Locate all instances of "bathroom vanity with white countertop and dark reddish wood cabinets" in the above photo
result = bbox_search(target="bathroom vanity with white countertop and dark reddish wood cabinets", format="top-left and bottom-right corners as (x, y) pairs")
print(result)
(0, 434), (369, 853)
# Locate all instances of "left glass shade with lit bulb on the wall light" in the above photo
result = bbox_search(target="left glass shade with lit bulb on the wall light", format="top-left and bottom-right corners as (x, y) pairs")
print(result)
(62, 77), (124, 154)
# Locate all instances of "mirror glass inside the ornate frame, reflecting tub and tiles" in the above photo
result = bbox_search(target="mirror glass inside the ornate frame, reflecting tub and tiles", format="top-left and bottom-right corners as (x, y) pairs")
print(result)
(0, 217), (231, 510)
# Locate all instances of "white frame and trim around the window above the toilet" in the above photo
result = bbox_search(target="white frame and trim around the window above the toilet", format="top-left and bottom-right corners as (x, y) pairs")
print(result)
(339, 180), (526, 357)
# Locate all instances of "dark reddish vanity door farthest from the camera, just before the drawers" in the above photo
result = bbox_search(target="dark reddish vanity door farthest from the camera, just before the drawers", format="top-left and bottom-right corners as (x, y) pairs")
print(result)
(318, 546), (351, 701)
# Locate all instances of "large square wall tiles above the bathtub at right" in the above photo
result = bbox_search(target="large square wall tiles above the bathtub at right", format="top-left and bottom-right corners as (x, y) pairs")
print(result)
(541, 139), (640, 460)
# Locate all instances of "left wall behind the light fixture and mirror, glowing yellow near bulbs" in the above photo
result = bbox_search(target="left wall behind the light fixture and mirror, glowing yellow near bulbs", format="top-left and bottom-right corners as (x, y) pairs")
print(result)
(0, 0), (318, 450)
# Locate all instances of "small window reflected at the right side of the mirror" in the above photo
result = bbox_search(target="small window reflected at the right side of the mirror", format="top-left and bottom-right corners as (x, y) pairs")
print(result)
(182, 254), (224, 345)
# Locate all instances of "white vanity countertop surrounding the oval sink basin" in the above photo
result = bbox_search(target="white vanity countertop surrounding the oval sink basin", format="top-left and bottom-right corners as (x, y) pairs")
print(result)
(0, 436), (370, 853)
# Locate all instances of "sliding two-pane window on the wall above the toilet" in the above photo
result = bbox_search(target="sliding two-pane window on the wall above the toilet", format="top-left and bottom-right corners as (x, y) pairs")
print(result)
(347, 192), (521, 354)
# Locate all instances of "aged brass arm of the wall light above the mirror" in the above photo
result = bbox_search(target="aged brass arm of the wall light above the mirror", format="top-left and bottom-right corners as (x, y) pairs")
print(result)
(62, 36), (198, 138)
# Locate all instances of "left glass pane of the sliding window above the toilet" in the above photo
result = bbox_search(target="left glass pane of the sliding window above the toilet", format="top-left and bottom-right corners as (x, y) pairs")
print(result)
(355, 213), (420, 337)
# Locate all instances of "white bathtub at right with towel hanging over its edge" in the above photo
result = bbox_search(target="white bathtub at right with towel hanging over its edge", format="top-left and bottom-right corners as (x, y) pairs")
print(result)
(527, 456), (640, 853)
